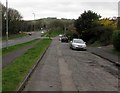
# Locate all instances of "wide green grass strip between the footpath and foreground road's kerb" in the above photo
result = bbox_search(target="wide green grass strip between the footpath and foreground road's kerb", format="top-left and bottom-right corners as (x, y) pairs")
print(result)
(2, 39), (51, 91)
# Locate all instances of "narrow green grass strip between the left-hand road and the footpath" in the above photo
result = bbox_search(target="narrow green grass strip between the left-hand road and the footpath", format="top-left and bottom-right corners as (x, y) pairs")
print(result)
(0, 39), (37, 55)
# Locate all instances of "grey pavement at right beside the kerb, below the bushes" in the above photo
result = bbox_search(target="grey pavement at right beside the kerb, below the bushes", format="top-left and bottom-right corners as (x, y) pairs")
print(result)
(88, 46), (120, 65)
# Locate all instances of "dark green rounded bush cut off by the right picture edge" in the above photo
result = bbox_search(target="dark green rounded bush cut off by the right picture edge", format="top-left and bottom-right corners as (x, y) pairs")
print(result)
(113, 30), (120, 51)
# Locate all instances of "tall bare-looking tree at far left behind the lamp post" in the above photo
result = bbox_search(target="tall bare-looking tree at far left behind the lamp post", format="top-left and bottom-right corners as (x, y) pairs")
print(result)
(0, 3), (22, 36)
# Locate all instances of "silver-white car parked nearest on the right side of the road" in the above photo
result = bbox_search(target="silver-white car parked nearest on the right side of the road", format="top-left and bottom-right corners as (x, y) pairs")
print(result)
(70, 39), (87, 50)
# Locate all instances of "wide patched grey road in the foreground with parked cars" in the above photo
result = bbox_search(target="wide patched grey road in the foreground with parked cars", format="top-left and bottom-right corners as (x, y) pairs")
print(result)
(24, 38), (118, 91)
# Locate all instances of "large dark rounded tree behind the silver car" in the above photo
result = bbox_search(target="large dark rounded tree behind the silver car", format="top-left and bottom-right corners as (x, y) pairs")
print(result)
(74, 10), (101, 41)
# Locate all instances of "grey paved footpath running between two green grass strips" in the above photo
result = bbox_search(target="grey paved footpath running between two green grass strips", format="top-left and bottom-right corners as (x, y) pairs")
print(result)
(2, 41), (39, 68)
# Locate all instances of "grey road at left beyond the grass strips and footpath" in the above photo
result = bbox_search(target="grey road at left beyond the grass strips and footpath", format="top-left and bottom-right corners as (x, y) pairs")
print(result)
(2, 31), (44, 48)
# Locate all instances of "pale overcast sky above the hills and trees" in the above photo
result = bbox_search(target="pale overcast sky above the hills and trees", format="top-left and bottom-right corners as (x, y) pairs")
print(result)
(0, 0), (120, 20)
